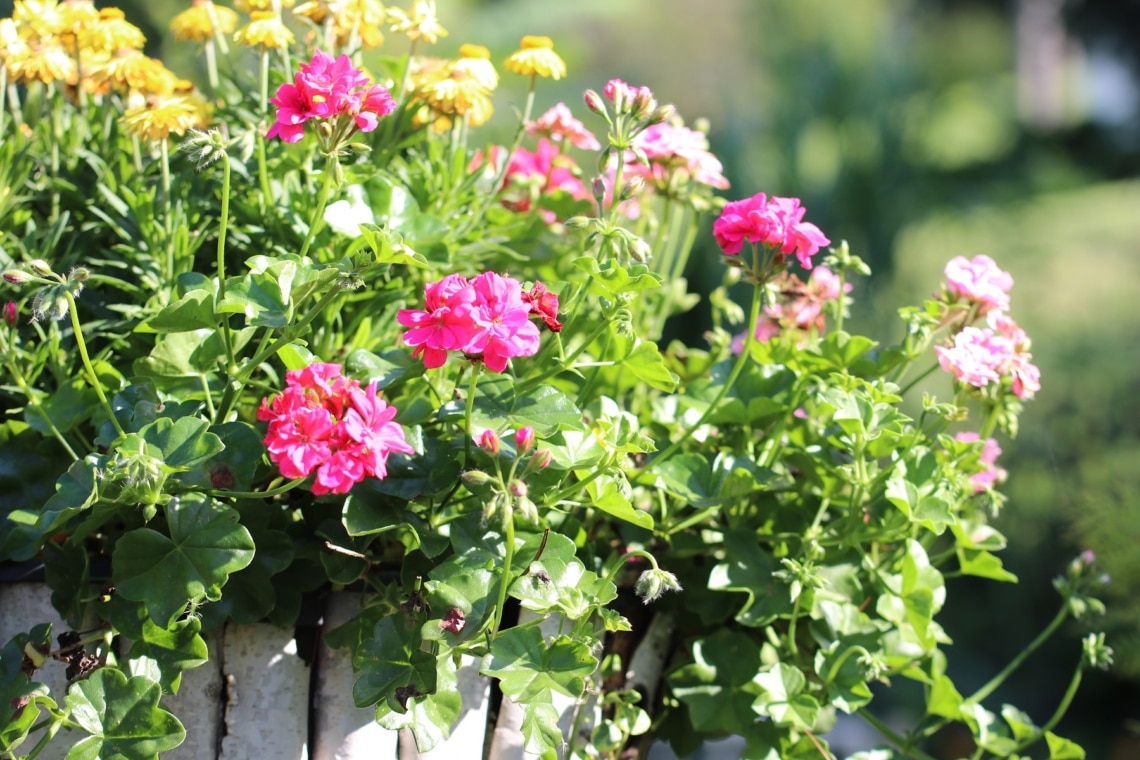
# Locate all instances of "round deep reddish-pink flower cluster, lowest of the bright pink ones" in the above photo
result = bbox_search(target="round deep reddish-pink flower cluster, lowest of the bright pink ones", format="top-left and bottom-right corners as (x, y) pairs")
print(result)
(258, 362), (415, 496)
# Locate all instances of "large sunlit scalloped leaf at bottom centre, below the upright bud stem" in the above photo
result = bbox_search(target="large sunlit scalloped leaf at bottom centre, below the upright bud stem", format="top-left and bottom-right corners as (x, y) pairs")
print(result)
(480, 626), (597, 703)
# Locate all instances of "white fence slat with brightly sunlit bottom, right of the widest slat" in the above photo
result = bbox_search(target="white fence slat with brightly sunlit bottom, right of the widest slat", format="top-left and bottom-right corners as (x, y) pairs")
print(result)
(312, 591), (399, 760)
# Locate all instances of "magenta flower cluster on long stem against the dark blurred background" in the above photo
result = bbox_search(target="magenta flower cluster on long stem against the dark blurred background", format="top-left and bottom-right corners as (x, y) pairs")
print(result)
(713, 193), (831, 269)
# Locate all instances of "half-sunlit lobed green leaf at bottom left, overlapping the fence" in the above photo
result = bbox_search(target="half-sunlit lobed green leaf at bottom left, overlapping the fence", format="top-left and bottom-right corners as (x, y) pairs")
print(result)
(66, 668), (186, 760)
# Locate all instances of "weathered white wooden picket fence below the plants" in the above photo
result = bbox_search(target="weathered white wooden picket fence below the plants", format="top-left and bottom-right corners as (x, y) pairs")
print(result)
(0, 582), (588, 760)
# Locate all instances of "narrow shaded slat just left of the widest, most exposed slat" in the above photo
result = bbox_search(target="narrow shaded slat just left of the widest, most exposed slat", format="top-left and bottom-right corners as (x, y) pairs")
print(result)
(162, 632), (225, 760)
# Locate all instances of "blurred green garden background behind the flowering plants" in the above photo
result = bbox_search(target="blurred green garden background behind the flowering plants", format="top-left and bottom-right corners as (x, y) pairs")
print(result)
(15, 0), (1140, 760)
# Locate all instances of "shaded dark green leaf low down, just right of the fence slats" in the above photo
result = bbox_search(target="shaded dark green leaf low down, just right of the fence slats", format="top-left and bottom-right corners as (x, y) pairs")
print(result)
(668, 628), (760, 734)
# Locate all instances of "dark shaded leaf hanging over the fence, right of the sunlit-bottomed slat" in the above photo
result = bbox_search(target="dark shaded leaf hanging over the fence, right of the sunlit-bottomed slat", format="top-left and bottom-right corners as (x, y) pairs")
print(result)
(352, 614), (435, 712)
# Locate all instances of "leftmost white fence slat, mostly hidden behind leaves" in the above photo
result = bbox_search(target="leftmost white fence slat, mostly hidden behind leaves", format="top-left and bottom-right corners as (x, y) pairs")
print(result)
(0, 583), (77, 760)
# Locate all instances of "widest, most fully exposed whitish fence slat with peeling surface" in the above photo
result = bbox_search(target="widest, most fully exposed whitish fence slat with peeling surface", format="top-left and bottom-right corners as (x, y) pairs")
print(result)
(221, 623), (309, 760)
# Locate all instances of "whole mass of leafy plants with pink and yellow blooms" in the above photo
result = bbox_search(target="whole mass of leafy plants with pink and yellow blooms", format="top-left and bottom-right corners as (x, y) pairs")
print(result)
(0, 0), (1109, 759)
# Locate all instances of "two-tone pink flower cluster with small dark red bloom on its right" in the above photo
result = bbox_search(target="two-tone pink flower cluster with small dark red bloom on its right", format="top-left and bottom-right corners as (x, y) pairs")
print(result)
(397, 272), (562, 373)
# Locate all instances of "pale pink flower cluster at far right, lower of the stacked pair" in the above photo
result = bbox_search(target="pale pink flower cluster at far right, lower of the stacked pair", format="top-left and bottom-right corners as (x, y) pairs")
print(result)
(935, 311), (1041, 399)
